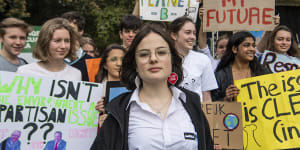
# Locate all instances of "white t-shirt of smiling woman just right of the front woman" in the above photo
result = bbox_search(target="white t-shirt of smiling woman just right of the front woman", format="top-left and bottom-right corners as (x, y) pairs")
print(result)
(180, 50), (218, 101)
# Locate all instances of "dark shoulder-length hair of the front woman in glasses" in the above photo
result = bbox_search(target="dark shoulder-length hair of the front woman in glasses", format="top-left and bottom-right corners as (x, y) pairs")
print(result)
(121, 24), (183, 90)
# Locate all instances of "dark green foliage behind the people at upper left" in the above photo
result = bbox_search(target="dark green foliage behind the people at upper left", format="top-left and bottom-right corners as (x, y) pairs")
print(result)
(0, 0), (135, 54)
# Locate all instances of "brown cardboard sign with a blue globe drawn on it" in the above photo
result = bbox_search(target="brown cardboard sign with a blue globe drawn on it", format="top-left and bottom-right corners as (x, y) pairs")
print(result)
(201, 102), (243, 149)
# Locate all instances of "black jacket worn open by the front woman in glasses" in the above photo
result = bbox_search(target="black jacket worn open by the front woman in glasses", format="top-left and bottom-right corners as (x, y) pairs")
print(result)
(91, 89), (213, 150)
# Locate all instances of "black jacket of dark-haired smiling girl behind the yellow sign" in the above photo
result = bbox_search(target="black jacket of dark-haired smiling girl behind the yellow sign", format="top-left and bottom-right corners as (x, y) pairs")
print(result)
(210, 65), (270, 101)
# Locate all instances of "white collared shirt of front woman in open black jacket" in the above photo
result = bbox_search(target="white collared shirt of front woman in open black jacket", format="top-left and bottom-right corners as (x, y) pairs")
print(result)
(127, 87), (198, 150)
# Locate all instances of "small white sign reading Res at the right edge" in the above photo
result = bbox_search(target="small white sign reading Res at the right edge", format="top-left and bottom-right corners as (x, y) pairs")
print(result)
(260, 50), (300, 72)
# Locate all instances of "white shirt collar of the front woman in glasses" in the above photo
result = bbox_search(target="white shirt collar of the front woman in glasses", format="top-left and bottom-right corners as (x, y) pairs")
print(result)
(126, 86), (186, 110)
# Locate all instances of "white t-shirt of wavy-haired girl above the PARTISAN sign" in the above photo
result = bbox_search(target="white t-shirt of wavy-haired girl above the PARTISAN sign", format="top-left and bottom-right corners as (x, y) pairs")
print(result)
(17, 62), (81, 81)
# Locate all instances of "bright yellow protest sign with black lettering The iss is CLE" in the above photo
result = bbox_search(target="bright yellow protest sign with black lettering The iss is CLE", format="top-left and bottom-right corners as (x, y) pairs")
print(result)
(235, 70), (300, 150)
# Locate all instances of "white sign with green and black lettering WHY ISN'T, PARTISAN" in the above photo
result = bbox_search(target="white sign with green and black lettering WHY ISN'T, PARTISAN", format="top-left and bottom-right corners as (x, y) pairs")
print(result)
(0, 71), (102, 150)
